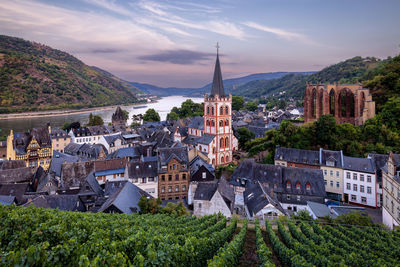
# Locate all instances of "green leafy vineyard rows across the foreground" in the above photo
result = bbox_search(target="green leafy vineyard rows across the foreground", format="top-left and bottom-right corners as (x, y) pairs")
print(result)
(0, 205), (400, 267)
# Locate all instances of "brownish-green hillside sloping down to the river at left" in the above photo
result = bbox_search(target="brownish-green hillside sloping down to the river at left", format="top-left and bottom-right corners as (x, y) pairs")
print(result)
(0, 35), (143, 113)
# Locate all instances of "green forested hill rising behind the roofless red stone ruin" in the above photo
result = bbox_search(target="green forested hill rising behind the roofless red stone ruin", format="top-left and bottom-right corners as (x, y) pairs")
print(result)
(232, 57), (386, 99)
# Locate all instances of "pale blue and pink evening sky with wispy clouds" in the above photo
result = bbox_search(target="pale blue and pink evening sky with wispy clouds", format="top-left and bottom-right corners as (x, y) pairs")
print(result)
(0, 0), (400, 87)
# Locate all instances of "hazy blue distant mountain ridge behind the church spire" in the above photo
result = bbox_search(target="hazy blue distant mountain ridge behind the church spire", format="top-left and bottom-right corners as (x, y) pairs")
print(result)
(131, 72), (313, 97)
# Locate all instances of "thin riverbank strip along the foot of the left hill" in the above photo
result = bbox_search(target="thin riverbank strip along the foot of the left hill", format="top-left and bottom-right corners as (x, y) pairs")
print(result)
(0, 101), (152, 120)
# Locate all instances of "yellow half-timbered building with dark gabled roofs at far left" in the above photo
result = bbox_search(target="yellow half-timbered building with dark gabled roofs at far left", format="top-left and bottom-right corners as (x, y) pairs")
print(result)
(7, 128), (53, 170)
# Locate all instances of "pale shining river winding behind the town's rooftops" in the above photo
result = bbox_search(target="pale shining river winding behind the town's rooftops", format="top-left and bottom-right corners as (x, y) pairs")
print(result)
(0, 96), (204, 135)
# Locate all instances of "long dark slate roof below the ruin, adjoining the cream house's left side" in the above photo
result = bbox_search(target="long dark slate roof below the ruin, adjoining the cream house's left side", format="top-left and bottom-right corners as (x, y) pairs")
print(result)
(275, 146), (320, 165)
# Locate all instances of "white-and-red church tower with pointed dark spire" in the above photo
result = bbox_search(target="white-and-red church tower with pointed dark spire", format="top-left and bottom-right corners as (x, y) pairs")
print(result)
(204, 44), (237, 167)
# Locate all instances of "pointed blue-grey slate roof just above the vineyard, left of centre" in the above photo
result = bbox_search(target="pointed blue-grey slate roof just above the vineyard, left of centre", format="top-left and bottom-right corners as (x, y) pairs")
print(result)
(98, 182), (150, 214)
